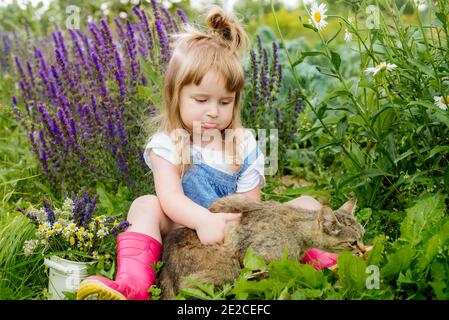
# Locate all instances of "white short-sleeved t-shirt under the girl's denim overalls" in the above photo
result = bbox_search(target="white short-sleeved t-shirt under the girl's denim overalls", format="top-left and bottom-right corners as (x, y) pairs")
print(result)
(143, 132), (266, 192)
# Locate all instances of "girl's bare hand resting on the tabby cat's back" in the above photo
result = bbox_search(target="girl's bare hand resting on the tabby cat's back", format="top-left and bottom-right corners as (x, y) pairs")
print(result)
(195, 212), (242, 245)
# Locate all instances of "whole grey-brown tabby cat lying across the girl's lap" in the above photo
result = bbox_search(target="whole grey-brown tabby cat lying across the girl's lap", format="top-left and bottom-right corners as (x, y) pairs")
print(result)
(158, 194), (365, 299)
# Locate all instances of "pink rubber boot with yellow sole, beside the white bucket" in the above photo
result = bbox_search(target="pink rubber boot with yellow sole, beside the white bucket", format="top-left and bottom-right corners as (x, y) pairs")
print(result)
(76, 231), (162, 300)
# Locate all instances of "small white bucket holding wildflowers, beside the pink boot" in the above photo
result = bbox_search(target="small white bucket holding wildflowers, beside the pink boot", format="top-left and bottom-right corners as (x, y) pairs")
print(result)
(44, 256), (88, 300)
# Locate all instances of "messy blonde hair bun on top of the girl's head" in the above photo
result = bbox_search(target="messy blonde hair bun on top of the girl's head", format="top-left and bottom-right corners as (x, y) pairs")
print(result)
(206, 6), (249, 57)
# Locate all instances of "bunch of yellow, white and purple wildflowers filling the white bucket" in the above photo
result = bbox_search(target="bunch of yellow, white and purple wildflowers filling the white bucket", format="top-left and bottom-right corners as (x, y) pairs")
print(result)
(17, 193), (129, 262)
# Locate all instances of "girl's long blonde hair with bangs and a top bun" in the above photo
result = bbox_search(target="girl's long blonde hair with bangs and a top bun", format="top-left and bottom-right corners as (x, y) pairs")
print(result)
(145, 6), (249, 177)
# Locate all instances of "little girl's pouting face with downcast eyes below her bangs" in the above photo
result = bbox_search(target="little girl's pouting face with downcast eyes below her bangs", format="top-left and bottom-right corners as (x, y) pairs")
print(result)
(179, 71), (235, 141)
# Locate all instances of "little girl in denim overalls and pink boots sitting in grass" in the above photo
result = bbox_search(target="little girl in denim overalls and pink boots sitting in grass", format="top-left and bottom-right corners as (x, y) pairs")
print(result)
(77, 6), (336, 300)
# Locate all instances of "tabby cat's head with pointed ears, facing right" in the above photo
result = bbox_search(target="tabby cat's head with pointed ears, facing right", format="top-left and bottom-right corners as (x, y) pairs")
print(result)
(317, 198), (366, 255)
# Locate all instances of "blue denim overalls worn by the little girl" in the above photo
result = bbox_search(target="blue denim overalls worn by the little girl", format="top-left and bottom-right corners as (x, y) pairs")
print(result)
(182, 145), (261, 208)
